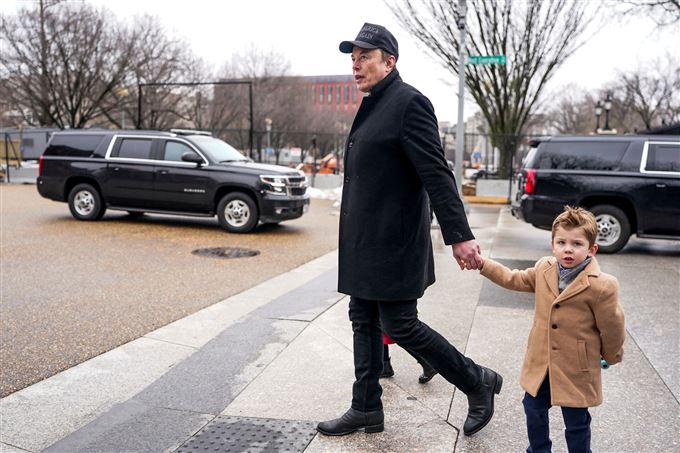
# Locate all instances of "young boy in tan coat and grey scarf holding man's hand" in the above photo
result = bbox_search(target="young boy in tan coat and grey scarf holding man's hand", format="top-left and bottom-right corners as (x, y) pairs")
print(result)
(481, 206), (626, 453)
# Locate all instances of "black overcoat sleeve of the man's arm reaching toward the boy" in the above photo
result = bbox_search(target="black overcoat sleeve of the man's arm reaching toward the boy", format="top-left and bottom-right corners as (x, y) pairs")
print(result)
(401, 94), (475, 245)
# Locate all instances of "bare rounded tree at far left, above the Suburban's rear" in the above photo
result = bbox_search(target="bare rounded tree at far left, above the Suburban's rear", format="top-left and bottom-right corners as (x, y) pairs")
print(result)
(0, 0), (134, 128)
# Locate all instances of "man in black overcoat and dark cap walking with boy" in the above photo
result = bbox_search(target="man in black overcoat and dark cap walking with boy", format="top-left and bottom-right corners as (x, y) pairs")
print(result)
(317, 23), (503, 436)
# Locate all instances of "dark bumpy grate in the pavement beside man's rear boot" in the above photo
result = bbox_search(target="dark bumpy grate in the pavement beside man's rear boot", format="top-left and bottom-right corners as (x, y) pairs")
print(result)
(176, 416), (316, 453)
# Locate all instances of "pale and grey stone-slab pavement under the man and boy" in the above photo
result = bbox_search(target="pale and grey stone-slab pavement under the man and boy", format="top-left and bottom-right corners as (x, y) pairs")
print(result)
(0, 205), (680, 453)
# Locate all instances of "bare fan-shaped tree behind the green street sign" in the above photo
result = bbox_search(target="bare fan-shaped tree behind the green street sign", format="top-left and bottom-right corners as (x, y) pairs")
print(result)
(386, 0), (591, 176)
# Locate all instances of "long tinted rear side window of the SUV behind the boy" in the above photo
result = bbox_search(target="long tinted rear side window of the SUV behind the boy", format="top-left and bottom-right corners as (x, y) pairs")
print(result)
(534, 141), (629, 170)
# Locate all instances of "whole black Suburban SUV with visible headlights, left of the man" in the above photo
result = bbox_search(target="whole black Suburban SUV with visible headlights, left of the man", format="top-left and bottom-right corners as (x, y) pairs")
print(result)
(37, 130), (309, 233)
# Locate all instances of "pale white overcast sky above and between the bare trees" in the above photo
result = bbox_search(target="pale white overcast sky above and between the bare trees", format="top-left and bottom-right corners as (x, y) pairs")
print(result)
(0, 0), (680, 122)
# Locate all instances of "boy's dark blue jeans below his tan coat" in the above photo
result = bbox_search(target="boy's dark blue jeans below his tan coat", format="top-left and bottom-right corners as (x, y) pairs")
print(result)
(522, 375), (591, 453)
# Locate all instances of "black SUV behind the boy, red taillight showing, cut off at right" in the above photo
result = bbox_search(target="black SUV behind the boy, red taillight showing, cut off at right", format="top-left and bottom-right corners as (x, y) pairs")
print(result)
(512, 135), (680, 253)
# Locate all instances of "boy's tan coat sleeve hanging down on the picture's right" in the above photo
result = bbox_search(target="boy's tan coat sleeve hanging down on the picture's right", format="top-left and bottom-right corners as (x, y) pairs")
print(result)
(592, 277), (626, 364)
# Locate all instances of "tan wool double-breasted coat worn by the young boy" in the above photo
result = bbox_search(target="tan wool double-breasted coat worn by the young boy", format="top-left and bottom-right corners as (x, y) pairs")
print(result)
(481, 256), (626, 407)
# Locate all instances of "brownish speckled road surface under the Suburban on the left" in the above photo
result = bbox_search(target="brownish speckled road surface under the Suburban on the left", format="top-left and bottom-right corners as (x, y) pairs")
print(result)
(0, 184), (338, 397)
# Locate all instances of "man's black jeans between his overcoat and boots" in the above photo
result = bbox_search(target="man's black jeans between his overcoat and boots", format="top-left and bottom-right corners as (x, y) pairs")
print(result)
(349, 297), (481, 412)
